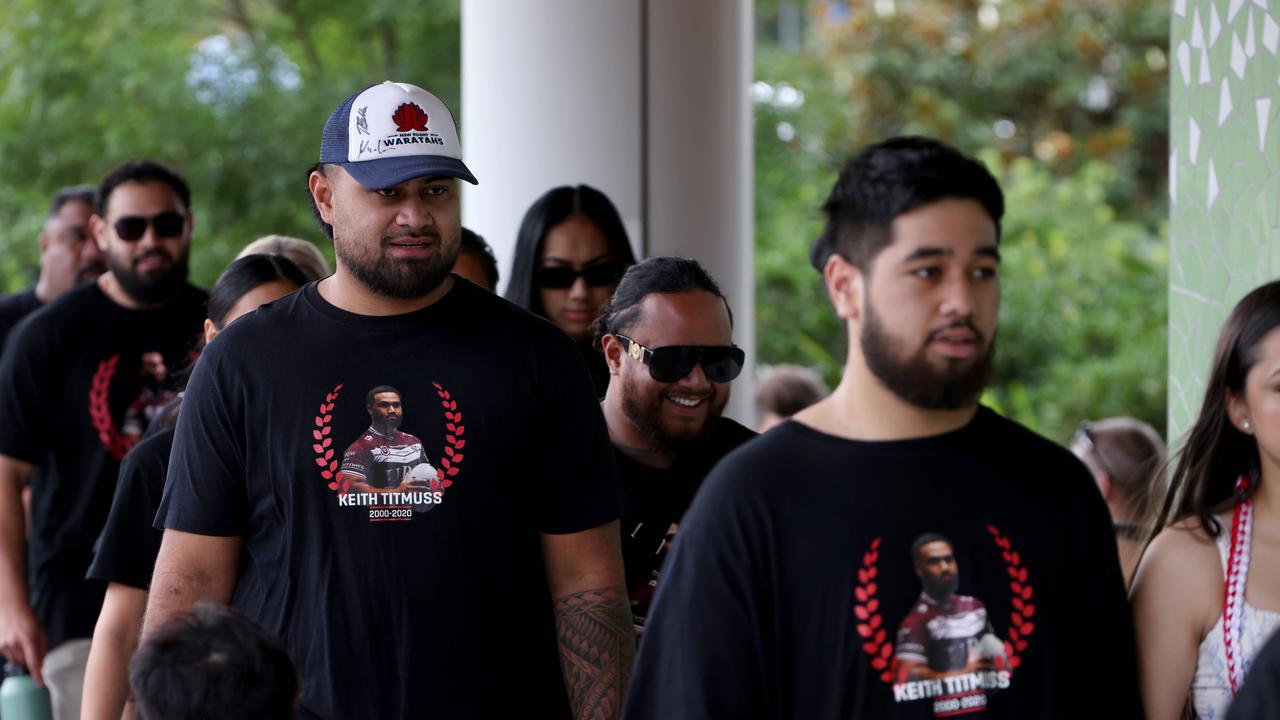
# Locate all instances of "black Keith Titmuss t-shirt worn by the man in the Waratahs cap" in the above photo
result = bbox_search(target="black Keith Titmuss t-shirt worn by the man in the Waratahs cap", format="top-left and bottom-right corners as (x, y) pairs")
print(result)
(156, 283), (621, 719)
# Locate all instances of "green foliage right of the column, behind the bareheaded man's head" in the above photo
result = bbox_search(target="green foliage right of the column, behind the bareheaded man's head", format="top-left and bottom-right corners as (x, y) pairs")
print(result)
(754, 0), (1169, 441)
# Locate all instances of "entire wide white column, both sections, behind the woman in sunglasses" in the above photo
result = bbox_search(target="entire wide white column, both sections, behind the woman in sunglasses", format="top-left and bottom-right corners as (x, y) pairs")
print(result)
(458, 0), (755, 424)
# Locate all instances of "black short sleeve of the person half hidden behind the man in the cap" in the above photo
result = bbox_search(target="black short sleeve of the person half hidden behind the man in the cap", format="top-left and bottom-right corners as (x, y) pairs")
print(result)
(86, 428), (174, 589)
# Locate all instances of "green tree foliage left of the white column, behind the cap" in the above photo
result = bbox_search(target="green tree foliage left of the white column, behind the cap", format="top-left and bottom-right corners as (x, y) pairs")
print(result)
(0, 0), (461, 291)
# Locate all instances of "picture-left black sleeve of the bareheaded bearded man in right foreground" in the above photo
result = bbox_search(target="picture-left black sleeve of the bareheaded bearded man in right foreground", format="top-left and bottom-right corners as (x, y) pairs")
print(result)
(625, 459), (777, 720)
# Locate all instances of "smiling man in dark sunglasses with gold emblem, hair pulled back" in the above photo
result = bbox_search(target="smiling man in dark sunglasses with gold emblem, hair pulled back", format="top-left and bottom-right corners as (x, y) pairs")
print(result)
(595, 258), (755, 633)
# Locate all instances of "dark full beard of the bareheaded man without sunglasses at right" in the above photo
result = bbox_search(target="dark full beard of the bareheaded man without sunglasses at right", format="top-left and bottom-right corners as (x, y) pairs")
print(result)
(861, 299), (996, 410)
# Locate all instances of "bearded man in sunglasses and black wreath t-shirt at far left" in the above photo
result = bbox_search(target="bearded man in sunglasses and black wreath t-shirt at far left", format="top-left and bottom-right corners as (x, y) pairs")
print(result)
(0, 160), (206, 719)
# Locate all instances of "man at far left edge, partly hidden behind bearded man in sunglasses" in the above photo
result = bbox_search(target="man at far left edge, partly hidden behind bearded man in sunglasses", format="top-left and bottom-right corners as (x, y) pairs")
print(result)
(0, 184), (106, 350)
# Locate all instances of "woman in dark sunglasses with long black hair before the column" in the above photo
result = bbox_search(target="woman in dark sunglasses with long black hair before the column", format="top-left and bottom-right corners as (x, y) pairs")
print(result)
(504, 184), (636, 396)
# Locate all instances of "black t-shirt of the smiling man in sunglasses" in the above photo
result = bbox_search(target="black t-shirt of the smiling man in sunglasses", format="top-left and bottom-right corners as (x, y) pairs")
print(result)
(613, 418), (755, 626)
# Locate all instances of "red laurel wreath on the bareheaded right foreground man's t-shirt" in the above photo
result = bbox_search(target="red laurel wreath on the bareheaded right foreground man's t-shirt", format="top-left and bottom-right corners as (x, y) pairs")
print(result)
(854, 524), (1036, 683)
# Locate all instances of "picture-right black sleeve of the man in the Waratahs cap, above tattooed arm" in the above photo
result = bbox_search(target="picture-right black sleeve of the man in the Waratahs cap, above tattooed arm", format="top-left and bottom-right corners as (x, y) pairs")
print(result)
(531, 331), (622, 534)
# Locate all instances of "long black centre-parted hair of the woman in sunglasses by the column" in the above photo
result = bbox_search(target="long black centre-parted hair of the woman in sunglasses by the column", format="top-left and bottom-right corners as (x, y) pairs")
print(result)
(503, 184), (636, 318)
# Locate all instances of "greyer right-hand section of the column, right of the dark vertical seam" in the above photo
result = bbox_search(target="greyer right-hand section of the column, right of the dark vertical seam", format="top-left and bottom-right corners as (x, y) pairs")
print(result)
(645, 0), (755, 425)
